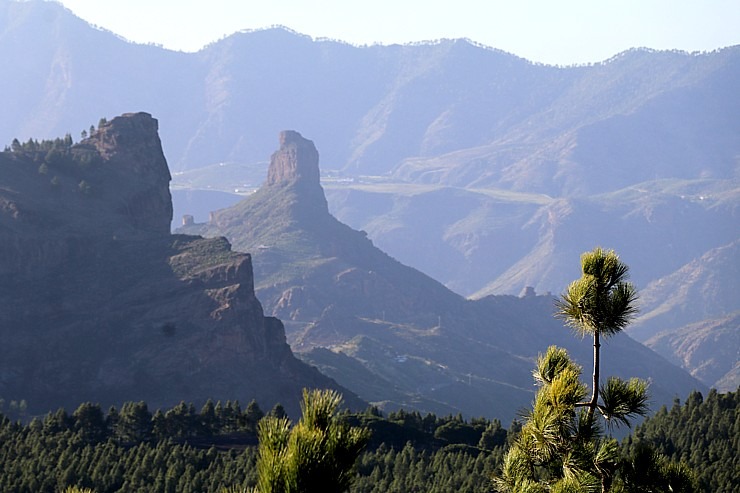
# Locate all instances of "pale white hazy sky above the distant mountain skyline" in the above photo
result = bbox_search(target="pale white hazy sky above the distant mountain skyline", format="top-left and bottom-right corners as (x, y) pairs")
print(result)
(53, 0), (740, 64)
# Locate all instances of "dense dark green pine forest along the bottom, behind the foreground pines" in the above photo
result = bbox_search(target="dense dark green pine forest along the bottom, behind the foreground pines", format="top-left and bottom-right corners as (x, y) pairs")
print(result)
(0, 391), (740, 493)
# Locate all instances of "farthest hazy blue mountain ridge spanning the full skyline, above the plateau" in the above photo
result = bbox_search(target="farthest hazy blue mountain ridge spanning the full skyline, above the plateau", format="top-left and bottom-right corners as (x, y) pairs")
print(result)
(0, 0), (740, 195)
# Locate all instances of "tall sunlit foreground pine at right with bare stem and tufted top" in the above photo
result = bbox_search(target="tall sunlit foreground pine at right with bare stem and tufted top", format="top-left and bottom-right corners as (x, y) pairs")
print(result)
(494, 248), (691, 493)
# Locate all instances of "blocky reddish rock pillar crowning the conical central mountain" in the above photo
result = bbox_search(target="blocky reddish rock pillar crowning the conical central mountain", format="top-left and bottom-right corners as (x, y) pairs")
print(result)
(267, 130), (320, 187)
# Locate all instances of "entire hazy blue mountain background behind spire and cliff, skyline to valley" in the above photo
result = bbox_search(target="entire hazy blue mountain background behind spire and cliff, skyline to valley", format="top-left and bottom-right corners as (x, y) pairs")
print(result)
(0, 0), (740, 388)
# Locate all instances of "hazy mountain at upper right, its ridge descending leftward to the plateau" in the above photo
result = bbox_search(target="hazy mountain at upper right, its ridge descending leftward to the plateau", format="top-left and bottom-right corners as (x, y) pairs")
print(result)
(395, 48), (740, 195)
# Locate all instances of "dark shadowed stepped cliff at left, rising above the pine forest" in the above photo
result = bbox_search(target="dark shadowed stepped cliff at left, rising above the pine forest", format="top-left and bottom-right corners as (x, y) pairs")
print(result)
(0, 113), (358, 412)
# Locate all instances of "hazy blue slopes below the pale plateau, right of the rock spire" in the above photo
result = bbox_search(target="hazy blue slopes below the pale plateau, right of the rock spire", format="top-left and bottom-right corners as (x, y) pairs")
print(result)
(327, 180), (738, 298)
